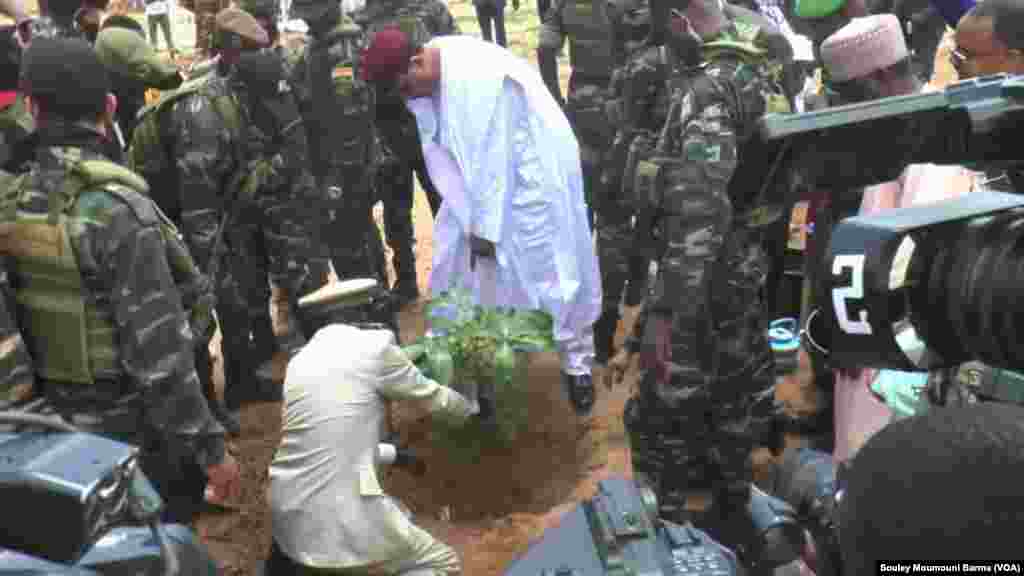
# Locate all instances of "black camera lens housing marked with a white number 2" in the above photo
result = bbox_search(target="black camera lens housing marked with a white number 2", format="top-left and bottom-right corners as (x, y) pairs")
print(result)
(824, 192), (1024, 371)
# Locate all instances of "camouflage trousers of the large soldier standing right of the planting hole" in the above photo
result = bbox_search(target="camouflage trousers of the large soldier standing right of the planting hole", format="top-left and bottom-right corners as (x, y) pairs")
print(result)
(623, 371), (773, 523)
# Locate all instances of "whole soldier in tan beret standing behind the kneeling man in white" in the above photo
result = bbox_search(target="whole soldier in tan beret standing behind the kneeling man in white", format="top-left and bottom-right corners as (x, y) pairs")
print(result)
(131, 8), (322, 410)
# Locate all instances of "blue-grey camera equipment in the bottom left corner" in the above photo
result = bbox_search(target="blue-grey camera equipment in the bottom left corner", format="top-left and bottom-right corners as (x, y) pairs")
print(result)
(0, 412), (219, 576)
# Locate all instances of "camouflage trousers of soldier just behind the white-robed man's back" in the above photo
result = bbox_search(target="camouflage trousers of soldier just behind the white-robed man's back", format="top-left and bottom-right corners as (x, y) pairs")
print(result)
(565, 81), (614, 228)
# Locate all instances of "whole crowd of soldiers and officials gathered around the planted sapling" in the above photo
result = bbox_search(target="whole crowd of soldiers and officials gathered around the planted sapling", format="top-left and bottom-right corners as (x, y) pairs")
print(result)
(0, 0), (1024, 574)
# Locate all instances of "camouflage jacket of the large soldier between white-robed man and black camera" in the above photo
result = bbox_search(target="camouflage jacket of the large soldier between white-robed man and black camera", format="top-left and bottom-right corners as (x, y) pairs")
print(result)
(631, 29), (784, 405)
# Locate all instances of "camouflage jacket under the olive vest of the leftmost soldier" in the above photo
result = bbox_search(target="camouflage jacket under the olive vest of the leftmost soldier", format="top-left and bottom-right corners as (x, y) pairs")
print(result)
(0, 124), (224, 467)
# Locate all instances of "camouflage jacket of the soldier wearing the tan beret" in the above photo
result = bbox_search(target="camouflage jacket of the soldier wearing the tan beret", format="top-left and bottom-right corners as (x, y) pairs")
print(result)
(161, 71), (316, 293)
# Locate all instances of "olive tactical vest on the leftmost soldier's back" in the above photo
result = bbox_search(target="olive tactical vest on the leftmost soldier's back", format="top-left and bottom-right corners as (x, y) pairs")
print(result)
(0, 160), (195, 384)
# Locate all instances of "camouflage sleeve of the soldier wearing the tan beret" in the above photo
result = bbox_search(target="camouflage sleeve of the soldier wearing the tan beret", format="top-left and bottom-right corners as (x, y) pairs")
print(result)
(171, 94), (233, 270)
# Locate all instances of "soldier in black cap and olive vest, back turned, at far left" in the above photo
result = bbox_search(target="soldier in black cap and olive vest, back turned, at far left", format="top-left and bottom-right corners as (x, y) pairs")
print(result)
(0, 38), (239, 522)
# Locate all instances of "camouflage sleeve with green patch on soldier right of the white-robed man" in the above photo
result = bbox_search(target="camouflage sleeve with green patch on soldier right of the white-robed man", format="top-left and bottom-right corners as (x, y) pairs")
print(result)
(647, 84), (737, 340)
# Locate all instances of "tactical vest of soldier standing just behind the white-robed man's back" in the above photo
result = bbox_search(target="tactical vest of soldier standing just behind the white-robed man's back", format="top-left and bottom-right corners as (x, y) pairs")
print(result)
(562, 0), (615, 78)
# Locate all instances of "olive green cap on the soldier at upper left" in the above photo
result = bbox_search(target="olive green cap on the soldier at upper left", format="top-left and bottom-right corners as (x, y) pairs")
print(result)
(95, 27), (180, 89)
